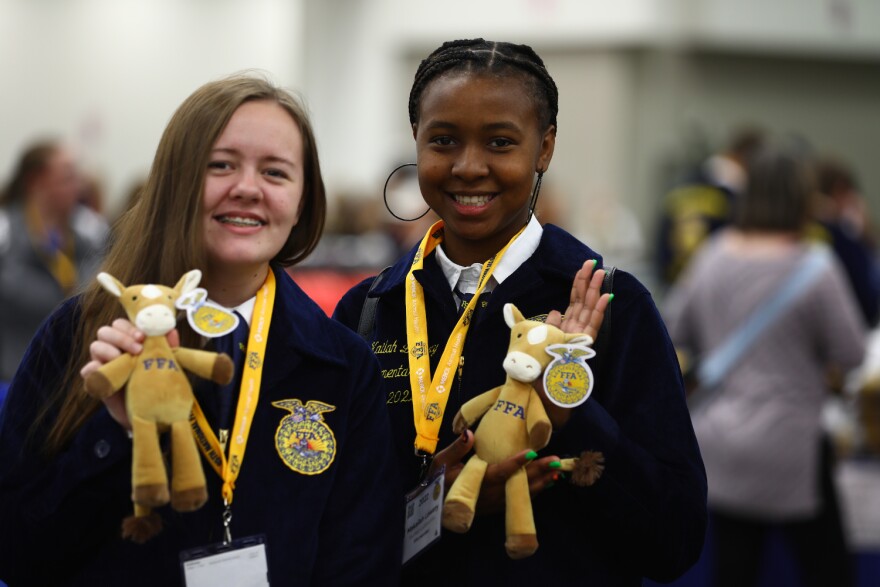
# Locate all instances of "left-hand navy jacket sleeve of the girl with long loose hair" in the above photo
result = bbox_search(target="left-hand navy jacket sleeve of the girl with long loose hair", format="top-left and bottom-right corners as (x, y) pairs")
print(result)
(0, 302), (131, 585)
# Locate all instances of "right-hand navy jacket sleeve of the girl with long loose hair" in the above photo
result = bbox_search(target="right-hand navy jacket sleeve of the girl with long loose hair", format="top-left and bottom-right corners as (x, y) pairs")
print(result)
(312, 341), (404, 586)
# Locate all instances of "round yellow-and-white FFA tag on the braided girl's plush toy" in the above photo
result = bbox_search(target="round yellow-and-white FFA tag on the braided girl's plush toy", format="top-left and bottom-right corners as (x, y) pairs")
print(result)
(544, 344), (596, 408)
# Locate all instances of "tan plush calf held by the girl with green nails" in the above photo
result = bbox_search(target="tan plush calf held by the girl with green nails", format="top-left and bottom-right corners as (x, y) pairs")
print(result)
(443, 304), (602, 559)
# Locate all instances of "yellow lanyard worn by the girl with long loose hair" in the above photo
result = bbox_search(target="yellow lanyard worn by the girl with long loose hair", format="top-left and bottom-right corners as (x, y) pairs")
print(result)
(190, 268), (275, 505)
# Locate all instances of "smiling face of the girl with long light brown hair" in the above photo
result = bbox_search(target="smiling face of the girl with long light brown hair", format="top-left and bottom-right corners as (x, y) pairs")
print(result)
(202, 101), (303, 290)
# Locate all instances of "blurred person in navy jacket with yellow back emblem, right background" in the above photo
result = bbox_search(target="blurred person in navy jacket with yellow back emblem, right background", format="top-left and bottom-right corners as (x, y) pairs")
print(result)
(656, 127), (766, 286)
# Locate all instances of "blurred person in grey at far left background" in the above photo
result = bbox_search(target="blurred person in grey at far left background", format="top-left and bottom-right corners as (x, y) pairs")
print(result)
(0, 140), (108, 394)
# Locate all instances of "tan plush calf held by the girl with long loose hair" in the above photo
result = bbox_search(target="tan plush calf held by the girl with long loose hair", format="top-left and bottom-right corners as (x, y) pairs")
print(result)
(85, 270), (233, 542)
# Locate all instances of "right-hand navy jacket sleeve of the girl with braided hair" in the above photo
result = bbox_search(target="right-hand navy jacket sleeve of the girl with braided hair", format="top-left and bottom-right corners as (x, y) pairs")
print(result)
(556, 272), (707, 581)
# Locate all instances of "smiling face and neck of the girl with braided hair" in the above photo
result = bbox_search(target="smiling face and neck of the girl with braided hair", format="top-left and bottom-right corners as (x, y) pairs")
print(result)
(413, 72), (556, 265)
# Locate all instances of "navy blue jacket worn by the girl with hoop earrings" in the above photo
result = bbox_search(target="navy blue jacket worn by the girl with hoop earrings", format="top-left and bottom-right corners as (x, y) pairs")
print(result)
(335, 226), (706, 587)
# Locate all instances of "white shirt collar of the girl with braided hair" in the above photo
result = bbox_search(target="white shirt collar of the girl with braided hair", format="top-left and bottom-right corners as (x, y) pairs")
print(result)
(436, 215), (544, 304)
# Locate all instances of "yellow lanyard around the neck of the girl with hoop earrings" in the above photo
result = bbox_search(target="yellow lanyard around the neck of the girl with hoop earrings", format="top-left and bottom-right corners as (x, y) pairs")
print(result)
(405, 220), (524, 454)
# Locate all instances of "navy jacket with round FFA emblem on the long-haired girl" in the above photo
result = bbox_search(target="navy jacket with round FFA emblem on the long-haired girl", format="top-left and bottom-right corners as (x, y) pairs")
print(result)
(0, 269), (403, 587)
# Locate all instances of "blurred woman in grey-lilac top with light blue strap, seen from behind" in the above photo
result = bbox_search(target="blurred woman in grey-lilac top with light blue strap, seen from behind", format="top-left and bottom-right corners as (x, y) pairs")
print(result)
(664, 148), (865, 587)
